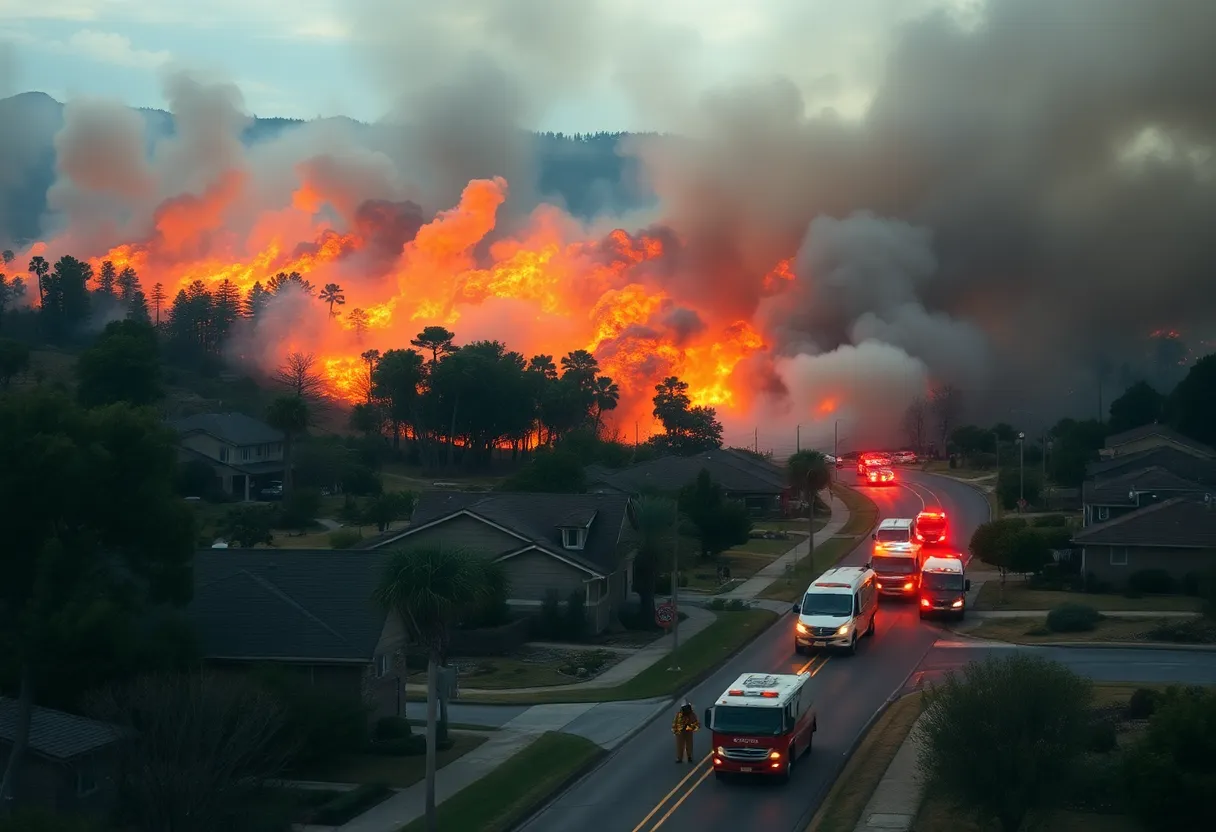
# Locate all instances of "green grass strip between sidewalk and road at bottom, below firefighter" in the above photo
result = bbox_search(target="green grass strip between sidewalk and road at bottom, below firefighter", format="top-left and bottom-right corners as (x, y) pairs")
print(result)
(401, 731), (604, 832)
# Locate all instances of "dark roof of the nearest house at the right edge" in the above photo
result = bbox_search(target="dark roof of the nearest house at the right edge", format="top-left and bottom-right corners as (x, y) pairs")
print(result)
(1073, 494), (1216, 549)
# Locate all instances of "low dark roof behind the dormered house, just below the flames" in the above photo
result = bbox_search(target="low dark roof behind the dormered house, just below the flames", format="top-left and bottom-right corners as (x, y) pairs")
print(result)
(589, 450), (786, 494)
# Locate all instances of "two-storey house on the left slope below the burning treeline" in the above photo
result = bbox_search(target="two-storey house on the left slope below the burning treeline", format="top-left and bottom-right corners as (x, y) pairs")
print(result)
(170, 414), (283, 500)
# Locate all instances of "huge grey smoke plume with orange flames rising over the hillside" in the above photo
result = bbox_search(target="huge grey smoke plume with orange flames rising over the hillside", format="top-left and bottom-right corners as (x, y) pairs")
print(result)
(9, 0), (1216, 448)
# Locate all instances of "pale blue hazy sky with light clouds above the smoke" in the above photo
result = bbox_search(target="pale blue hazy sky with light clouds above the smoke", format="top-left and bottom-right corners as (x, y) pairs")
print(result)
(0, 0), (968, 131)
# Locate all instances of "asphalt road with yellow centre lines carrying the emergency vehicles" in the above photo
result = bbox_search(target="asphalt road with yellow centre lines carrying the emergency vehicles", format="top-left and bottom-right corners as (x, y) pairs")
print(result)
(519, 468), (989, 832)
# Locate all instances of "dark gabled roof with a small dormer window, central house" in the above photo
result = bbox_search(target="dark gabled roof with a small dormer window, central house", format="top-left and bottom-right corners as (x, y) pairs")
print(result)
(364, 491), (629, 577)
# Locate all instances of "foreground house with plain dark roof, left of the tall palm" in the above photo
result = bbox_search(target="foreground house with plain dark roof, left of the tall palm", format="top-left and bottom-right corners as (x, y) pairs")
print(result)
(187, 549), (405, 715)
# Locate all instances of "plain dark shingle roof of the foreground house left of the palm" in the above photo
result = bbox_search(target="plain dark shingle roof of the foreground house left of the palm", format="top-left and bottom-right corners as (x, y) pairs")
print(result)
(188, 549), (387, 662)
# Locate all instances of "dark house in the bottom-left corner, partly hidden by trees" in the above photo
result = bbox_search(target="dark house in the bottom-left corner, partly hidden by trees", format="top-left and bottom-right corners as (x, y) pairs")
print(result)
(0, 697), (120, 814)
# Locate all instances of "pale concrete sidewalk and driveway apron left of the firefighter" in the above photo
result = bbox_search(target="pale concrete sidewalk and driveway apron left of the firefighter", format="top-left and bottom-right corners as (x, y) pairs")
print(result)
(338, 699), (672, 832)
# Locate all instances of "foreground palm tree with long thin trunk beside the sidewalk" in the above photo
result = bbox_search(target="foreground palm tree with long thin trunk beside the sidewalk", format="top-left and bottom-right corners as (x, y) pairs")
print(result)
(375, 546), (506, 832)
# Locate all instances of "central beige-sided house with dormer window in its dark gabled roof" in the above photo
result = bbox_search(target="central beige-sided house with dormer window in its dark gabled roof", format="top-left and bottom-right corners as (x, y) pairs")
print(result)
(360, 491), (635, 633)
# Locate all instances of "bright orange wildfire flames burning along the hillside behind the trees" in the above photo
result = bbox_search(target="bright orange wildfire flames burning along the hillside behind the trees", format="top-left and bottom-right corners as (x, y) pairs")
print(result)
(28, 169), (797, 423)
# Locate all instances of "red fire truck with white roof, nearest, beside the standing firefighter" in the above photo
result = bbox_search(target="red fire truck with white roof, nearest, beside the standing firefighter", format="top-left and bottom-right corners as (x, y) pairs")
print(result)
(705, 673), (818, 782)
